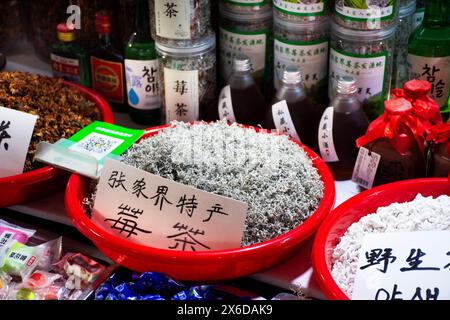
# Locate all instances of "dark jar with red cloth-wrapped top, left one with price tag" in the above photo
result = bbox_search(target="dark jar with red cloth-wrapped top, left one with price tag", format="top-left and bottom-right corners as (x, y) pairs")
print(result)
(356, 98), (425, 186)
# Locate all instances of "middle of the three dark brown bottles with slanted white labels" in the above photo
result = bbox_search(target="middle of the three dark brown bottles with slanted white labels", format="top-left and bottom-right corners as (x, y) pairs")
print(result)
(265, 66), (322, 153)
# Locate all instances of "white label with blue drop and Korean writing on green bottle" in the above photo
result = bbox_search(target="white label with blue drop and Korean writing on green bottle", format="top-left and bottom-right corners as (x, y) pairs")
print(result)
(125, 59), (159, 110)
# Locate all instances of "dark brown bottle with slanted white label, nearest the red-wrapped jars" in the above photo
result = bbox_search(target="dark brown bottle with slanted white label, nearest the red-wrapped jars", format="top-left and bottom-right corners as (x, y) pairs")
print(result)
(318, 76), (369, 180)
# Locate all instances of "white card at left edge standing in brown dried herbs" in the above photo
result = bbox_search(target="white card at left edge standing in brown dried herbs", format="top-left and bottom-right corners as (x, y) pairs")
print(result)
(0, 107), (38, 178)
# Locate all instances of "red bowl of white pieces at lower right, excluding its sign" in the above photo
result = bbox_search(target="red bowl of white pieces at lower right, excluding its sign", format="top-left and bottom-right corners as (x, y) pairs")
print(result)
(312, 178), (450, 300)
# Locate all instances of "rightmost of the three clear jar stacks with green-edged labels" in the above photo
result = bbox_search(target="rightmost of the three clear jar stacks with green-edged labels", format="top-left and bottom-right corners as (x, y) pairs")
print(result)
(329, 0), (400, 119)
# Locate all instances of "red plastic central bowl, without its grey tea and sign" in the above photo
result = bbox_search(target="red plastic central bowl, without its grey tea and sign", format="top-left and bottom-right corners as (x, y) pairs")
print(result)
(66, 126), (336, 282)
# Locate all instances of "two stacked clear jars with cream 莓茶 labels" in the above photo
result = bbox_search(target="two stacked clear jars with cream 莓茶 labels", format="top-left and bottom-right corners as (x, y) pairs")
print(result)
(149, 0), (216, 123)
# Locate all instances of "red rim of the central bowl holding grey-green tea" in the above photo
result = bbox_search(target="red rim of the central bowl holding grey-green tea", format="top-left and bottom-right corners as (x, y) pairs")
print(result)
(65, 125), (336, 280)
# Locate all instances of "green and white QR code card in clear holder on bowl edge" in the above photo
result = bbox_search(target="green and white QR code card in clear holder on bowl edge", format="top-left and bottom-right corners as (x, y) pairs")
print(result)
(34, 121), (144, 179)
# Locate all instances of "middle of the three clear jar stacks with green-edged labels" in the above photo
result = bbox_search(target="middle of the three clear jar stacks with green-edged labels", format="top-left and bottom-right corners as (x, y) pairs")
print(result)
(273, 0), (330, 104)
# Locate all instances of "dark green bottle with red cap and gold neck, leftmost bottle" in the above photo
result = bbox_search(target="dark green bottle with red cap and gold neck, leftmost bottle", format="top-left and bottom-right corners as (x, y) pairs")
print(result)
(50, 23), (91, 88)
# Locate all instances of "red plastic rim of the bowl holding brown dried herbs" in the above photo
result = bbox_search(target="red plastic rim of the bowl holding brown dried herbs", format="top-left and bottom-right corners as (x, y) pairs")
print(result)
(0, 81), (114, 208)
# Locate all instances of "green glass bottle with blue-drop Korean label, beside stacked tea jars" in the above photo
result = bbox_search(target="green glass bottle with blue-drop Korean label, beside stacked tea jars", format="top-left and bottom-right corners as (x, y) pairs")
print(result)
(125, 0), (161, 125)
